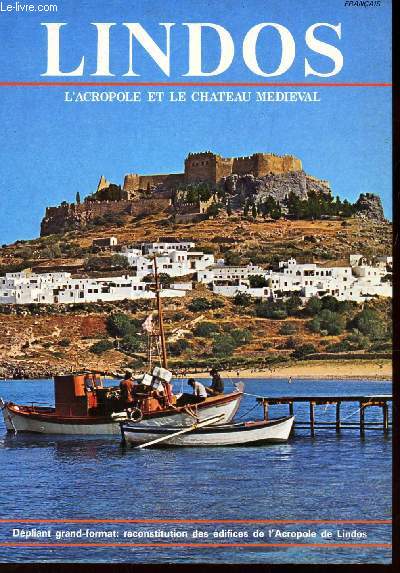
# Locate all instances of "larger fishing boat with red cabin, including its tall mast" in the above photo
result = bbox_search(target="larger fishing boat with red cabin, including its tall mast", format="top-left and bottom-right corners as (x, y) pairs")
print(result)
(0, 258), (243, 435)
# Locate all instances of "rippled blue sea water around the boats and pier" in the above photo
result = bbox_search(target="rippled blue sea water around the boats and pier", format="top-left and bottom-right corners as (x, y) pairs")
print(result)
(0, 379), (392, 563)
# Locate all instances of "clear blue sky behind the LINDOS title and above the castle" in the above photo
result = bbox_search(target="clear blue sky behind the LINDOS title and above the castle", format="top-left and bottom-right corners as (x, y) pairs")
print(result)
(0, 0), (391, 244)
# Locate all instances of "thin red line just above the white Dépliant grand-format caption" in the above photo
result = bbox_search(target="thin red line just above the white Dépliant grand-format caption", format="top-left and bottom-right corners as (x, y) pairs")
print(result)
(0, 518), (392, 525)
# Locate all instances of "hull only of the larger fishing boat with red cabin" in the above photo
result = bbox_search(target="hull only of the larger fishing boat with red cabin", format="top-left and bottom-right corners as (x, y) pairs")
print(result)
(1, 392), (243, 435)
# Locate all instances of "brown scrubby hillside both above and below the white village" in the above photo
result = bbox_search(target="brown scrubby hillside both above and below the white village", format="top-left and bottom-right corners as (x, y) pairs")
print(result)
(0, 213), (392, 377)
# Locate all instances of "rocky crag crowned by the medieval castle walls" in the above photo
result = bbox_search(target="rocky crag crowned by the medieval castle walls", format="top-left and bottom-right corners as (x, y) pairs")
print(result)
(40, 153), (384, 236)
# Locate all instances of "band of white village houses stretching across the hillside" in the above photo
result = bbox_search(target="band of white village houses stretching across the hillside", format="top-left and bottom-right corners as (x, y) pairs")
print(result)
(0, 241), (392, 304)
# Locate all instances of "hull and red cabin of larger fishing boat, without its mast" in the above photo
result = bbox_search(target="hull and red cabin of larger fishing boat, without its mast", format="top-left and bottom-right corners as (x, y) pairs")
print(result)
(0, 374), (243, 435)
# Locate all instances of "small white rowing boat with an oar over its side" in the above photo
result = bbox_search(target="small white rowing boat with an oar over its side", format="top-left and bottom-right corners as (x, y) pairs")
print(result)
(120, 416), (294, 449)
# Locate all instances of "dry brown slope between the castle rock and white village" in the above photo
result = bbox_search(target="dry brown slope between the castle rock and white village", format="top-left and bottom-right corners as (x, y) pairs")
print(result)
(0, 213), (392, 274)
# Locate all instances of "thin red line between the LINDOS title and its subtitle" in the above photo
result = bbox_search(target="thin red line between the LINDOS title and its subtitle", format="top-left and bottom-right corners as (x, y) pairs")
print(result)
(0, 82), (393, 88)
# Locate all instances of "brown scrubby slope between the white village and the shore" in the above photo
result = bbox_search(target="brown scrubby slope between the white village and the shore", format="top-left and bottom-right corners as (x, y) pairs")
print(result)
(0, 285), (390, 378)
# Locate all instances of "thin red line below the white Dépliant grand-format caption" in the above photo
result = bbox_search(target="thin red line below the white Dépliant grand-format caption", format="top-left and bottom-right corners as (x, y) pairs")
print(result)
(0, 541), (392, 549)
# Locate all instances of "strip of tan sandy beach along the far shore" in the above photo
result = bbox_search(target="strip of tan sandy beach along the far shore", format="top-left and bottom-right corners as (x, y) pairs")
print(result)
(194, 359), (392, 380)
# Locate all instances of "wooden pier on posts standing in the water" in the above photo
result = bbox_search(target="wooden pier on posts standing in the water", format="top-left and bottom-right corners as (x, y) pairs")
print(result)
(257, 394), (393, 436)
